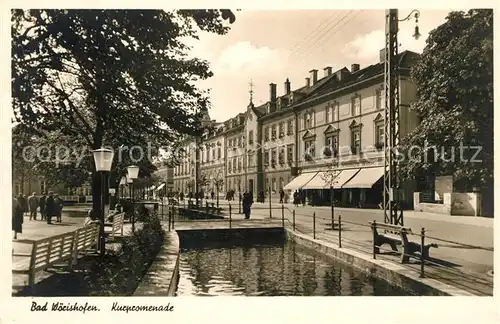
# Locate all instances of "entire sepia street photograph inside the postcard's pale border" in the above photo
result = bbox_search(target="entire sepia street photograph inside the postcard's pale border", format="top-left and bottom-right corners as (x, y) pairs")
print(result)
(3, 3), (495, 316)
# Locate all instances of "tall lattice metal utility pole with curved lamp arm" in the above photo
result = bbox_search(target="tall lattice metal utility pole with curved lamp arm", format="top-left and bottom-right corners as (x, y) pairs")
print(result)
(384, 9), (420, 226)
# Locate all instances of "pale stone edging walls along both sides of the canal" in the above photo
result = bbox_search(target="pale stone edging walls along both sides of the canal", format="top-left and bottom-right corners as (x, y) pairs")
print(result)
(134, 228), (475, 296)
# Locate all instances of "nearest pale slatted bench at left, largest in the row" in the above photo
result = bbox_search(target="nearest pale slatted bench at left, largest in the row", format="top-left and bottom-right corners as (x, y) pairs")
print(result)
(12, 232), (75, 287)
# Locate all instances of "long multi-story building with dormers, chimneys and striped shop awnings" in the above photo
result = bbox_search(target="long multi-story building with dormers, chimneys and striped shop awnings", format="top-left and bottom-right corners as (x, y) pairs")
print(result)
(170, 51), (418, 206)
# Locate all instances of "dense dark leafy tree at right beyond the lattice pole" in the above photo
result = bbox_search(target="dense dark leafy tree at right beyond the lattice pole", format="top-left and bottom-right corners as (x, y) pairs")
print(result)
(402, 9), (493, 190)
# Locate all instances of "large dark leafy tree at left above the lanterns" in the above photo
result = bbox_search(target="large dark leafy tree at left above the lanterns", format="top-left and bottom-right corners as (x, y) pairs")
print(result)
(12, 9), (235, 213)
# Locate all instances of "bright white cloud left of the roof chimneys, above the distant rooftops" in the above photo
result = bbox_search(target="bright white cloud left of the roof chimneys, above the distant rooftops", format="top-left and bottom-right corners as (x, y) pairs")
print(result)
(213, 41), (285, 75)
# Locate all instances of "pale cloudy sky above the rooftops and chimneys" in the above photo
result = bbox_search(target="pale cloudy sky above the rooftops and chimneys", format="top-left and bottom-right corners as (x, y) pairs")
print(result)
(188, 9), (451, 122)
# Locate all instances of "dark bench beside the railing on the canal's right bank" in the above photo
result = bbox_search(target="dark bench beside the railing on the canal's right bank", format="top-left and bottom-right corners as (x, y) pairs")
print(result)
(370, 222), (438, 263)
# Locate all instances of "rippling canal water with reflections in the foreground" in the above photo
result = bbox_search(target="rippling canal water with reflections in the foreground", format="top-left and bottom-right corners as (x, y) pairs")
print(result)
(177, 243), (411, 296)
